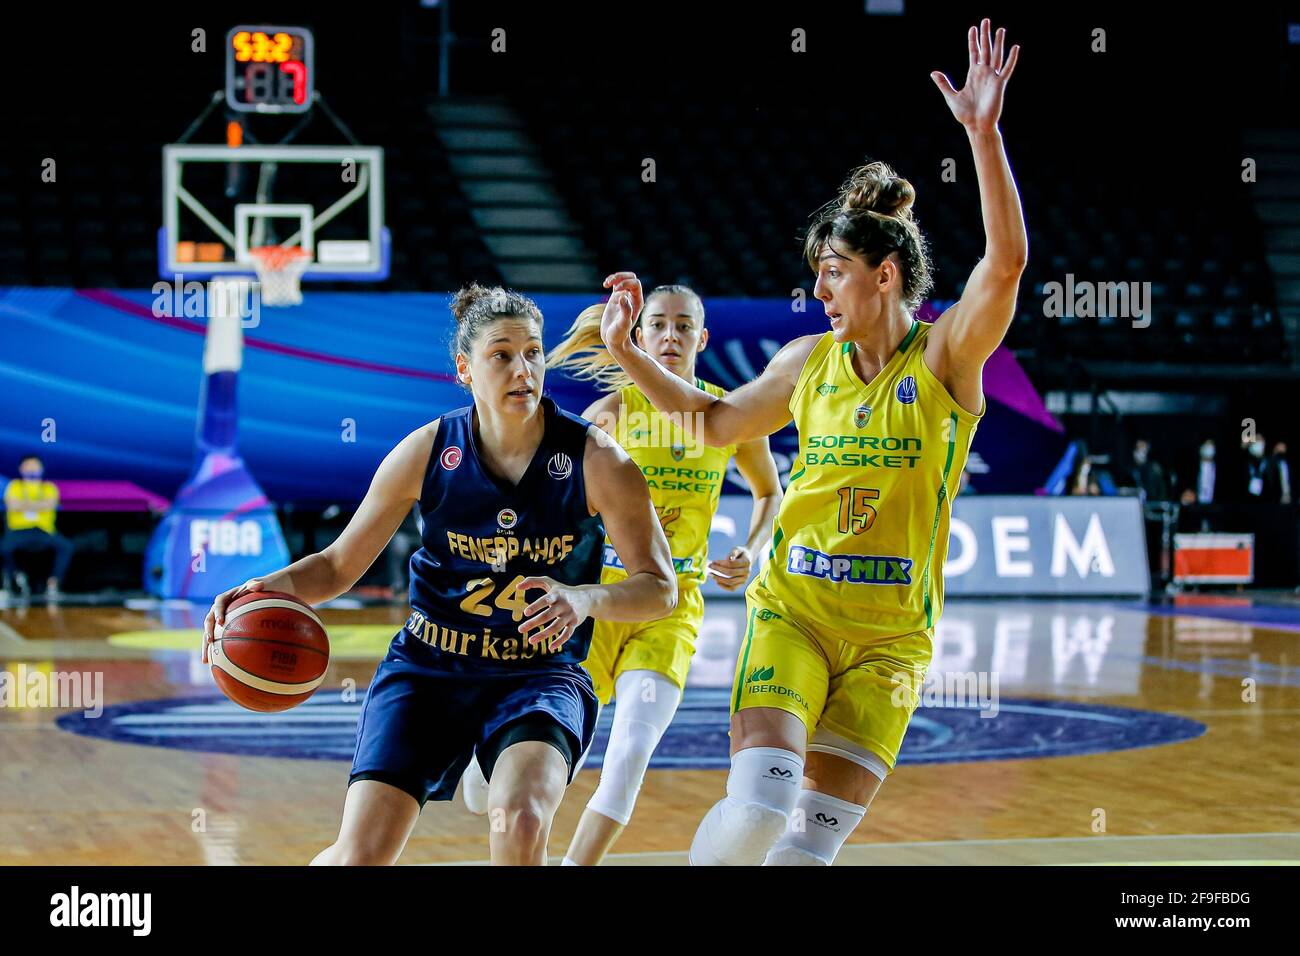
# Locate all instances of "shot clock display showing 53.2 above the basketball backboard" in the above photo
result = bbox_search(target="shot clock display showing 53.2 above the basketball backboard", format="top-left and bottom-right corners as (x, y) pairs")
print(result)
(226, 26), (316, 113)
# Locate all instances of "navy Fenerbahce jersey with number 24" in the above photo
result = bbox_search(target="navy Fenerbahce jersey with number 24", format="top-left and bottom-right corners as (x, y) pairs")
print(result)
(403, 398), (605, 671)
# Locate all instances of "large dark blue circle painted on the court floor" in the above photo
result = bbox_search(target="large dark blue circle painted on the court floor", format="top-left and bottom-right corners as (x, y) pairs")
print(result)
(57, 688), (1205, 770)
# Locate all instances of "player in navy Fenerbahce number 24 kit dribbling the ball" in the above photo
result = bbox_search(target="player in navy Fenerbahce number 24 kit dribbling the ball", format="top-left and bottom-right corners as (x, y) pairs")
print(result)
(204, 285), (677, 865)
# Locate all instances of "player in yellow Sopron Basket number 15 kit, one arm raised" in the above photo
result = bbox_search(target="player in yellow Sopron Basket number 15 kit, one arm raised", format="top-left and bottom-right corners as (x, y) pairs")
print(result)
(601, 20), (1028, 866)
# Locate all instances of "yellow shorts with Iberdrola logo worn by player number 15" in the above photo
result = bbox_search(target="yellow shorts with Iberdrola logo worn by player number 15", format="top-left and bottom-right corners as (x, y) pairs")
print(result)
(731, 589), (933, 773)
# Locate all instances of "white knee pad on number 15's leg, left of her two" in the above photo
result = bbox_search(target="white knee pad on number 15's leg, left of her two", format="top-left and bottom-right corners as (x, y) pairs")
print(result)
(690, 747), (803, 866)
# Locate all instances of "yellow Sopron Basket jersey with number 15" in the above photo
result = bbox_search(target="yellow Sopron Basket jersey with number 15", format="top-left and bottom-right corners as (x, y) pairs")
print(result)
(749, 320), (980, 644)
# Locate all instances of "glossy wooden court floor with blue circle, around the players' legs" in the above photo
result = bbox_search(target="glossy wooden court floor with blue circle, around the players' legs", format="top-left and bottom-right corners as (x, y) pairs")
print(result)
(0, 600), (1300, 865)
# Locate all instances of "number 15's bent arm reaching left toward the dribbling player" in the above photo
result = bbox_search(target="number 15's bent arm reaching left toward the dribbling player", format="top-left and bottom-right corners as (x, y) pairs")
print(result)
(601, 272), (819, 447)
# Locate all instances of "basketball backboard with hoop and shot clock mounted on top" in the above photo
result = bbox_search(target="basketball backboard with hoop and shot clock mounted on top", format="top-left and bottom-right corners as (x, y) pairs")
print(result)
(157, 21), (391, 283)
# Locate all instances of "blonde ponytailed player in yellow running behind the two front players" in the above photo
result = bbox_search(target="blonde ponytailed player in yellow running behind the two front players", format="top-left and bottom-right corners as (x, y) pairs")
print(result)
(464, 285), (781, 866)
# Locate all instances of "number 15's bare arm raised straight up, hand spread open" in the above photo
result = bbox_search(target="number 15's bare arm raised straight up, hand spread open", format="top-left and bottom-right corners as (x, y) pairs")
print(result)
(926, 20), (1028, 412)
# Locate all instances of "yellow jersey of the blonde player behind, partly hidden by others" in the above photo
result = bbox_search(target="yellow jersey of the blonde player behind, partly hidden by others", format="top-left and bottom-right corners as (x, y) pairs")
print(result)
(601, 378), (736, 588)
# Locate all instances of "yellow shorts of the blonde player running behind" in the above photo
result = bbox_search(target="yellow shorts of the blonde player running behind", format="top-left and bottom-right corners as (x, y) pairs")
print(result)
(582, 588), (705, 704)
